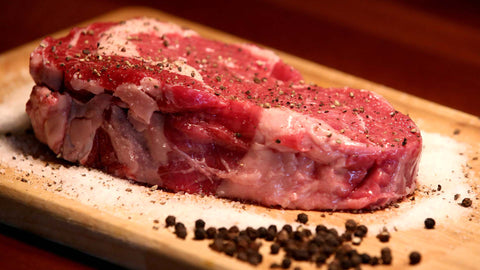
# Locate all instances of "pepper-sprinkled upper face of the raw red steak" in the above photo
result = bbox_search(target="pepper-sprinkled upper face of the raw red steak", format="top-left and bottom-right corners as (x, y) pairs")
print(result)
(31, 19), (421, 154)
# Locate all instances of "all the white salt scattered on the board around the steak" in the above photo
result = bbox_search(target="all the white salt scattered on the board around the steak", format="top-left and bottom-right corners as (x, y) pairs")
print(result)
(0, 132), (470, 231)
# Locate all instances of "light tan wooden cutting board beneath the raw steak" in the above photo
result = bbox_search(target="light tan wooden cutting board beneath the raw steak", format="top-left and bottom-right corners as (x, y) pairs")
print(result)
(0, 7), (480, 269)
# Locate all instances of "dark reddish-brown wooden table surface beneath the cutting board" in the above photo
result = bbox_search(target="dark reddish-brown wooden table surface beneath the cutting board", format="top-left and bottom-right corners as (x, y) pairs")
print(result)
(0, 0), (480, 269)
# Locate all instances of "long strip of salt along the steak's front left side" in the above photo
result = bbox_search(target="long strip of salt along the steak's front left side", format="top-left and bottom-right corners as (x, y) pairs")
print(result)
(0, 133), (285, 230)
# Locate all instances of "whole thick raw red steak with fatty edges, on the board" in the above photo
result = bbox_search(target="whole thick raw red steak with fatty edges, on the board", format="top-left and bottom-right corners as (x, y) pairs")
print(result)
(27, 18), (421, 209)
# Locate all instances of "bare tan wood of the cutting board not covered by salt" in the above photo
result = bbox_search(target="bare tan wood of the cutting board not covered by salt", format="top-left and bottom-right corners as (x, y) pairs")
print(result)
(0, 7), (480, 269)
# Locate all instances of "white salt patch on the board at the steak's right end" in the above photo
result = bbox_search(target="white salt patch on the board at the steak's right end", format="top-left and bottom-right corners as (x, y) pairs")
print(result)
(369, 132), (470, 231)
